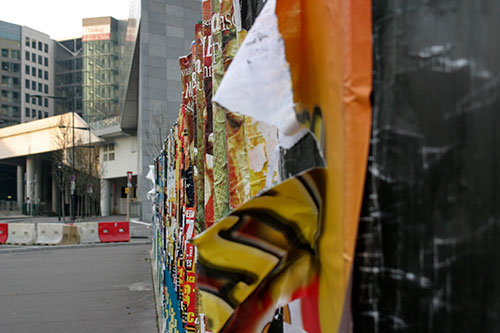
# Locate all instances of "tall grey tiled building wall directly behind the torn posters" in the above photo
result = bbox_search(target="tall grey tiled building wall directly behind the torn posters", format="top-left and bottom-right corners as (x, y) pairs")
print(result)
(137, 0), (201, 221)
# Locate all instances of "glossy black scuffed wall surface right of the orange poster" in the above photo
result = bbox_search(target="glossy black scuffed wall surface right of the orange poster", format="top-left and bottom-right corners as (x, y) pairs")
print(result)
(352, 0), (500, 333)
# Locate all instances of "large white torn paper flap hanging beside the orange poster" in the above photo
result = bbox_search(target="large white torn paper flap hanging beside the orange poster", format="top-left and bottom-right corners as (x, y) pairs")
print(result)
(213, 0), (300, 135)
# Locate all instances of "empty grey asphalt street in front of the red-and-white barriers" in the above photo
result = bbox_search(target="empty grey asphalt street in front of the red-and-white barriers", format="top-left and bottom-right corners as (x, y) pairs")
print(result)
(0, 245), (157, 333)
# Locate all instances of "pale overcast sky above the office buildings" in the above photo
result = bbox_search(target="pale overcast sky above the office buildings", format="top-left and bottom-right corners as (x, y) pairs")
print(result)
(0, 0), (130, 40)
